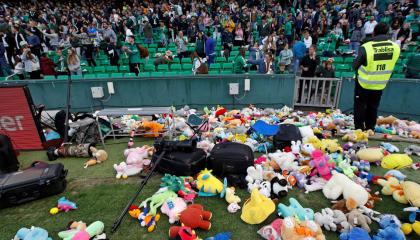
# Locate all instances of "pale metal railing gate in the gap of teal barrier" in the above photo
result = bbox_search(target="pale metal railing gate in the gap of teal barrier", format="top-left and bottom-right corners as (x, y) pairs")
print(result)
(293, 77), (341, 108)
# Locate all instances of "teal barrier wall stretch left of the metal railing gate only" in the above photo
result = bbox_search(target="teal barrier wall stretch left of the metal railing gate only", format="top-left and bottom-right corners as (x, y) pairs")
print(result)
(1, 74), (295, 111)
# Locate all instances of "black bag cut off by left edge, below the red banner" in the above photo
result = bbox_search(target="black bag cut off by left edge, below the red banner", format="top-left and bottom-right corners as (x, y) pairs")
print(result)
(0, 134), (19, 174)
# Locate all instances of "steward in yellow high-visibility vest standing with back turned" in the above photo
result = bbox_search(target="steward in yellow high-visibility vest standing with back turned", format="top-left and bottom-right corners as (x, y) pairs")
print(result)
(353, 23), (401, 130)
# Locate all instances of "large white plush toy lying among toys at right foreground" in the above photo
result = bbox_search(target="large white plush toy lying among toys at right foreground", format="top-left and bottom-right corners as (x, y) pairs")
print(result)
(322, 171), (369, 206)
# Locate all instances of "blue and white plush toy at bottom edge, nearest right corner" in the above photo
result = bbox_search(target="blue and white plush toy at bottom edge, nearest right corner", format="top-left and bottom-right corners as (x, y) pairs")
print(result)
(373, 214), (405, 240)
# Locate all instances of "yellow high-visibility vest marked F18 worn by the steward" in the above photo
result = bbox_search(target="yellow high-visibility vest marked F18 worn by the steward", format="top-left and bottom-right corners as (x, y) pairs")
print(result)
(357, 40), (401, 90)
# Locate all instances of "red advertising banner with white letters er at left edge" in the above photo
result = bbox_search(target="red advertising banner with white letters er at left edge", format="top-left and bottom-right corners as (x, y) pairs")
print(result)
(0, 86), (43, 150)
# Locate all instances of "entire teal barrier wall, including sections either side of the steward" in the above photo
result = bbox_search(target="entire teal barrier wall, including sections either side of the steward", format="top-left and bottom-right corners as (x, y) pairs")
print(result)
(3, 74), (420, 120)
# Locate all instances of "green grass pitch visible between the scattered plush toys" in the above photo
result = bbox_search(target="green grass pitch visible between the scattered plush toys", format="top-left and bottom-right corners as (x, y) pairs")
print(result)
(0, 139), (420, 240)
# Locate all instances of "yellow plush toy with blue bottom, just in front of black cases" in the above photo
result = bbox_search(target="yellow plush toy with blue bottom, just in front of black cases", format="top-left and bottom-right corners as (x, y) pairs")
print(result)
(197, 168), (225, 197)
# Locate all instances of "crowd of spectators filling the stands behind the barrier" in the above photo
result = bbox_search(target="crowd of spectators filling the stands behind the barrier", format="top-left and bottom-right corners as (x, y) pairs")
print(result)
(0, 0), (419, 79)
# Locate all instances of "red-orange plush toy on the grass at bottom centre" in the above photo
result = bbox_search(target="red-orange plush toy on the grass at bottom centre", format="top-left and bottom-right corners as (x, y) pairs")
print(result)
(179, 204), (212, 230)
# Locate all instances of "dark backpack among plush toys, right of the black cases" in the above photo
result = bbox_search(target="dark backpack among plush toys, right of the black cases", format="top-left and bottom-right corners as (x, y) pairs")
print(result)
(273, 124), (302, 150)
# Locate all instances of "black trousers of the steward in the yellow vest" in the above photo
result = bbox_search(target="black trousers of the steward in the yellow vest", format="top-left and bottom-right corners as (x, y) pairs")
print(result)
(354, 80), (382, 130)
